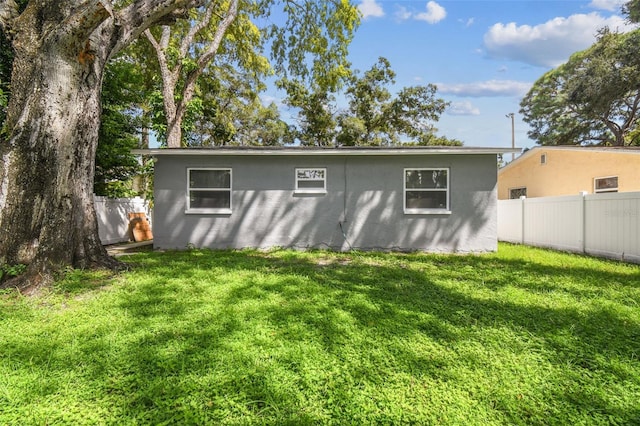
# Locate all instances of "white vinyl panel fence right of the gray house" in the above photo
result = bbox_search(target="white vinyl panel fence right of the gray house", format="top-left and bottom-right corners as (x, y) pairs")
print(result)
(498, 192), (640, 263)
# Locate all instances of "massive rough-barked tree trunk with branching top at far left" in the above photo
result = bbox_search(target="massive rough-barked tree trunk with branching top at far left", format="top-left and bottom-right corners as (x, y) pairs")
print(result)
(0, 0), (198, 288)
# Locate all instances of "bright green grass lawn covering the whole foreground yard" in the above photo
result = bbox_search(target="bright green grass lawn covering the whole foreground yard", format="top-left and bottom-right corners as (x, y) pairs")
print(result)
(0, 244), (640, 425)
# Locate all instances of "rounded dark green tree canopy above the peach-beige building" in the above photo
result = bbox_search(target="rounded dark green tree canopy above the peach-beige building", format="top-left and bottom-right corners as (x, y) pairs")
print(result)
(520, 30), (640, 146)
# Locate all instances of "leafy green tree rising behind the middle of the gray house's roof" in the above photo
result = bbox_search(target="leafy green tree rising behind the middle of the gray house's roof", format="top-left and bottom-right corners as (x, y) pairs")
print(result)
(280, 57), (461, 146)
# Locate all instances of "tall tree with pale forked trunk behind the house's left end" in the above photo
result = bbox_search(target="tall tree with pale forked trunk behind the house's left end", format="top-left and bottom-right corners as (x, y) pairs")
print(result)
(145, 0), (359, 147)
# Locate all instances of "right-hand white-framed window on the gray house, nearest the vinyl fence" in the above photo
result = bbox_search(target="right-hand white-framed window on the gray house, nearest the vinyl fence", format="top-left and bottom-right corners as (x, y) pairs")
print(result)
(404, 169), (451, 214)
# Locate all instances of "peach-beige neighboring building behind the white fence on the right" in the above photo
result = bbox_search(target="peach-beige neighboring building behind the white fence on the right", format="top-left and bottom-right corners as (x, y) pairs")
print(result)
(498, 146), (640, 200)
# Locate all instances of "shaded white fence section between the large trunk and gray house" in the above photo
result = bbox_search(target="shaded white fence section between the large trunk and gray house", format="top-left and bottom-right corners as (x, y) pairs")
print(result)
(94, 196), (151, 245)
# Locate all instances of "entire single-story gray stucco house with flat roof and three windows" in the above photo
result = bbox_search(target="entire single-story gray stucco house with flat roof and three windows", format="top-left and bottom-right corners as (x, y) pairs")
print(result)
(135, 147), (513, 252)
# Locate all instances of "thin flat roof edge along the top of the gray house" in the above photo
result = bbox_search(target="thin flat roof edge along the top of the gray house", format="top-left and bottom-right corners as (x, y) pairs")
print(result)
(131, 146), (522, 157)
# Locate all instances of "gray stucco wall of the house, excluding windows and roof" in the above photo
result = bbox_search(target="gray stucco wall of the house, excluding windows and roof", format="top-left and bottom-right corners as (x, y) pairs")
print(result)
(153, 154), (497, 252)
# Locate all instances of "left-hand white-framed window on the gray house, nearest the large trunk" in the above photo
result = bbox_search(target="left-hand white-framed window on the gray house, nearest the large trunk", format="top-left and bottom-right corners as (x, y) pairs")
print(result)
(187, 169), (231, 214)
